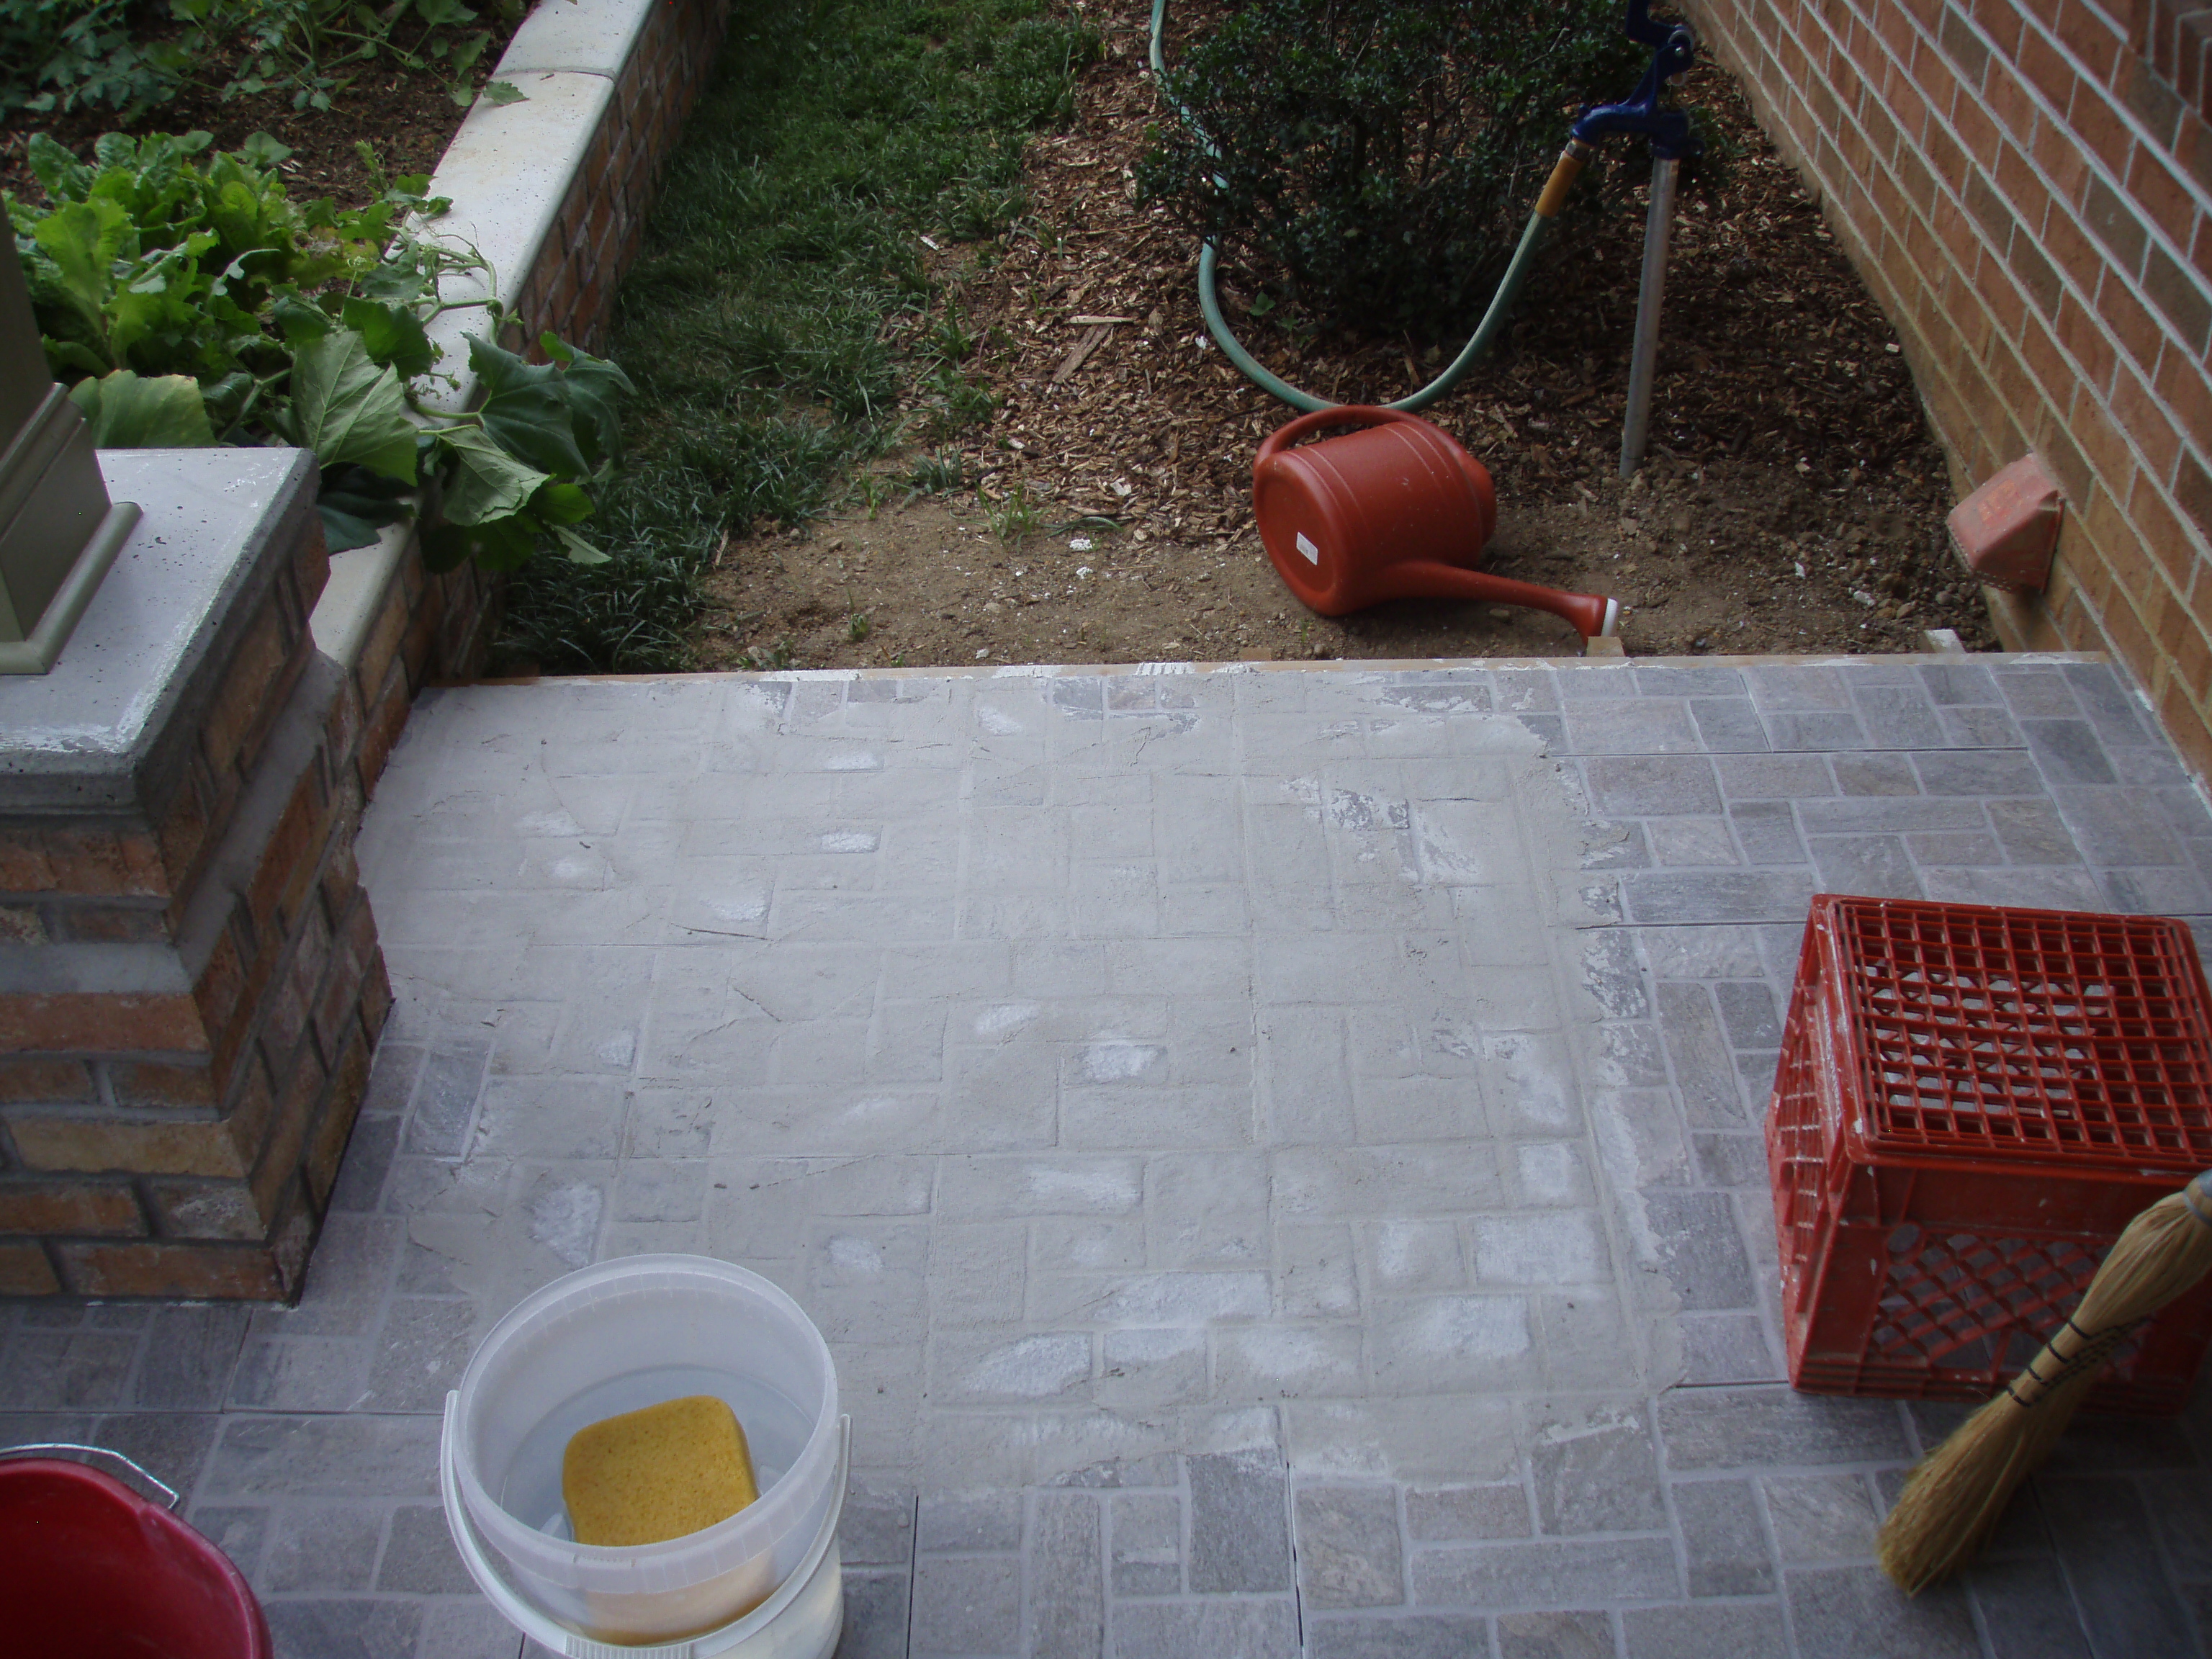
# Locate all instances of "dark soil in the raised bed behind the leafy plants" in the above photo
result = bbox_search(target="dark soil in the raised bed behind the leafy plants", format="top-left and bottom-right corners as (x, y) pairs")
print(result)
(0, 6), (520, 206)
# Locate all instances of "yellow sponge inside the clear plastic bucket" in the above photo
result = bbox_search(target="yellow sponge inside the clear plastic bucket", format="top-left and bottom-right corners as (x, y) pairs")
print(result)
(559, 1393), (761, 1544)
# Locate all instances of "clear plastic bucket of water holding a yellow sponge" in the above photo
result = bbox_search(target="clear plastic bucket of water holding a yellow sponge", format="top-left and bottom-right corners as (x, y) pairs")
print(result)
(444, 1256), (840, 1643)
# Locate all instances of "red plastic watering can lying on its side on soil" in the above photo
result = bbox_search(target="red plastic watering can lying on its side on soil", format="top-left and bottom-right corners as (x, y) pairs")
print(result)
(1252, 405), (1622, 639)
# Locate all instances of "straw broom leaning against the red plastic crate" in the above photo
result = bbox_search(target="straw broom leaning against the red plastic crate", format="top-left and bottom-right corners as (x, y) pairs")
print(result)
(1876, 1170), (2212, 1595)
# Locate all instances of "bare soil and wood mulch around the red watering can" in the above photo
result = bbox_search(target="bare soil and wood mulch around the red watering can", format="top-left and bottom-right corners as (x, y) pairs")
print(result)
(695, 0), (1995, 668)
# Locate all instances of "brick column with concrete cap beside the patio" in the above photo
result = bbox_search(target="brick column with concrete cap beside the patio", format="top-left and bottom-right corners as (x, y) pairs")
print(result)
(0, 449), (392, 1298)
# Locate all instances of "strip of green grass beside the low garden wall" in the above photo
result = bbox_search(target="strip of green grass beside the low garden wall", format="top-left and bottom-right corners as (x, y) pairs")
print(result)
(500, 0), (1097, 673)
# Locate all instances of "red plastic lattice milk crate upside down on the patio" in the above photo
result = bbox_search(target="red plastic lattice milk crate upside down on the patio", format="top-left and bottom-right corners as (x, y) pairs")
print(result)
(1768, 894), (2212, 1413)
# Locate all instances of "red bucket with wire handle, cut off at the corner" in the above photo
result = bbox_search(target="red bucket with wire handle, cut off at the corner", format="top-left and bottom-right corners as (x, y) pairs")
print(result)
(0, 1447), (272, 1659)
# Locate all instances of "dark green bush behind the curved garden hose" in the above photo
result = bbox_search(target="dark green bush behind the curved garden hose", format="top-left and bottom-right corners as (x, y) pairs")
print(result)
(1137, 0), (1646, 338)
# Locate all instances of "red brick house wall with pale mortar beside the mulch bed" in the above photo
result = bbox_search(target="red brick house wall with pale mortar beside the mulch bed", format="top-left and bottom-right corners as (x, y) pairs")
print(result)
(1688, 0), (2212, 774)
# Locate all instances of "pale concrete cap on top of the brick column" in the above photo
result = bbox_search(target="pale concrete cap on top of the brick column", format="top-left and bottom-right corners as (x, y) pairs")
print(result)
(0, 449), (314, 814)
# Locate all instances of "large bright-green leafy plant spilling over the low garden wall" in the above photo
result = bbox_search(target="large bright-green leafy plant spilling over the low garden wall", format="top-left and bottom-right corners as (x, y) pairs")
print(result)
(6, 132), (631, 571)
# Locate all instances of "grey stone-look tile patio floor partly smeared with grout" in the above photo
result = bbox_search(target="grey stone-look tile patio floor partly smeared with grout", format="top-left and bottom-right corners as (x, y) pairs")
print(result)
(0, 657), (2212, 1659)
